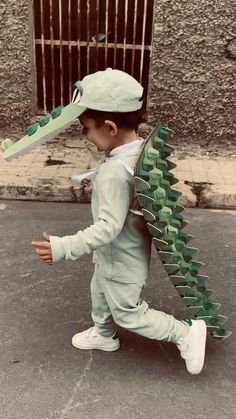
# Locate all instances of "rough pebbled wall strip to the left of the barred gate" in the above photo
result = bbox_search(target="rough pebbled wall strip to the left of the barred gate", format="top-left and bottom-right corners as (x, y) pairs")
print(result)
(0, 0), (33, 129)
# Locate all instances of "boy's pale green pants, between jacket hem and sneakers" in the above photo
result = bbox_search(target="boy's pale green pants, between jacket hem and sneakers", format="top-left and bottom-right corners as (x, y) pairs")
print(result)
(91, 265), (188, 343)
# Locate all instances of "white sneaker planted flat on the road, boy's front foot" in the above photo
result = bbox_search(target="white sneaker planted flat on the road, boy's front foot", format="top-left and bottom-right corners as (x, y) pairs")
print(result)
(72, 327), (120, 352)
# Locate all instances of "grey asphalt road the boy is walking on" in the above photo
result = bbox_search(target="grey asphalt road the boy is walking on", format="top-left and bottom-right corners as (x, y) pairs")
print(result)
(0, 201), (236, 419)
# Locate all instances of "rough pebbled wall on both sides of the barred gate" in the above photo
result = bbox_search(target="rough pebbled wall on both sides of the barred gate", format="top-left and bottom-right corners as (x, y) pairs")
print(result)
(0, 0), (236, 144)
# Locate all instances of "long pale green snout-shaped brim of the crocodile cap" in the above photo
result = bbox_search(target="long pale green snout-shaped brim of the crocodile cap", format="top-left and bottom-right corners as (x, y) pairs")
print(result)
(3, 103), (86, 160)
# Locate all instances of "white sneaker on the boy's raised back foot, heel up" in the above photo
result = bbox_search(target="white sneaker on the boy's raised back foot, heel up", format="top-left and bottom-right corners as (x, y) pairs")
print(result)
(176, 320), (207, 374)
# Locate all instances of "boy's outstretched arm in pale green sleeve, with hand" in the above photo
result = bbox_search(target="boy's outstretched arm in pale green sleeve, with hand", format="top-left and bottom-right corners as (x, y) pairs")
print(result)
(32, 160), (132, 263)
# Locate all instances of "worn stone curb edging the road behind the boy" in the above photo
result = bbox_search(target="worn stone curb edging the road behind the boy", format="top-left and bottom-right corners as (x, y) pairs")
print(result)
(0, 178), (236, 209)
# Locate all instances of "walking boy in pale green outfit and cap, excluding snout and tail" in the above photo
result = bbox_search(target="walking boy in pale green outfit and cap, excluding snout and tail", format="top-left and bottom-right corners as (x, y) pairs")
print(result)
(32, 69), (206, 374)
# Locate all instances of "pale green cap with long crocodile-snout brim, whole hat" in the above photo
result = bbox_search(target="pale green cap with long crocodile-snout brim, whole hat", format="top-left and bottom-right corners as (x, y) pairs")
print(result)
(2, 68), (143, 160)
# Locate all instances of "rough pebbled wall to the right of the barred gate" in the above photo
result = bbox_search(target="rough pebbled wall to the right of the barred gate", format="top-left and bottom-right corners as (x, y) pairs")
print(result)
(149, 0), (236, 144)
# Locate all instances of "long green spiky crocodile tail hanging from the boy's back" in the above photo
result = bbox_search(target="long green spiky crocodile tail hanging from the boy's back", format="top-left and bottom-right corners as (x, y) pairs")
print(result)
(135, 124), (231, 339)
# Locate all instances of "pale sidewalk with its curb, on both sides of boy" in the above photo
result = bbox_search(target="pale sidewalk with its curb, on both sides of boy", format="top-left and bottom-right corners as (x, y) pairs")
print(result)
(0, 138), (236, 209)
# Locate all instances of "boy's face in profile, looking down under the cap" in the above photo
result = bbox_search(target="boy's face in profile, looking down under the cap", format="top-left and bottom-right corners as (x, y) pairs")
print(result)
(79, 115), (116, 151)
